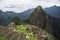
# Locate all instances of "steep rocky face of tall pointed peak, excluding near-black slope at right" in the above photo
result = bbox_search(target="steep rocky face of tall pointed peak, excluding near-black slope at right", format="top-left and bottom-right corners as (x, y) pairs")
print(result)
(29, 6), (52, 32)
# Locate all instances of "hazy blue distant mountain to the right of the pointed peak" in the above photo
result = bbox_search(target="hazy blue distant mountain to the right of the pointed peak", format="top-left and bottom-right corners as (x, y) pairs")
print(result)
(44, 5), (60, 18)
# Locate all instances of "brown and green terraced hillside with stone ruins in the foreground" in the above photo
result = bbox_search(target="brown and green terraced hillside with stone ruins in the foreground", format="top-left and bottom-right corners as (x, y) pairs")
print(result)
(0, 24), (55, 40)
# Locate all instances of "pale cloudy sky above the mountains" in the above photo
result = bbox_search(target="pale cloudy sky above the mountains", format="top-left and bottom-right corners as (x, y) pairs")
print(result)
(0, 0), (60, 12)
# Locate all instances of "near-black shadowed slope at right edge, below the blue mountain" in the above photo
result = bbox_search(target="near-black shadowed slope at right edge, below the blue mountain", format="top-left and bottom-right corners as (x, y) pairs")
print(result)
(51, 17), (60, 40)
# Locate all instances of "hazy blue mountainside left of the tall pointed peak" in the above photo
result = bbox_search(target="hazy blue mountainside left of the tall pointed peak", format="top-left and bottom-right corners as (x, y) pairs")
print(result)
(0, 8), (34, 25)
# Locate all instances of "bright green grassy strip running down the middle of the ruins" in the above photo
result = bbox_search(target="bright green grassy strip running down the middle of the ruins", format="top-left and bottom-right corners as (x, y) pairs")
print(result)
(17, 25), (37, 40)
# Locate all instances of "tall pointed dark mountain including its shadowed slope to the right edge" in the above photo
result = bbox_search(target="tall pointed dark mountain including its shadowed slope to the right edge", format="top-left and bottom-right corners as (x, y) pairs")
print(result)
(28, 6), (60, 40)
